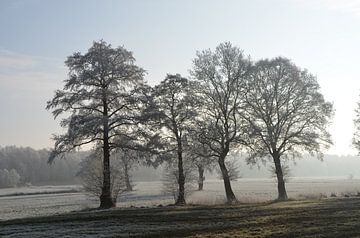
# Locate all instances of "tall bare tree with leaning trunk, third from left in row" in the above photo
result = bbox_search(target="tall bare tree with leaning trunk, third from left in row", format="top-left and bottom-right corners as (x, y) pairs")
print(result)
(191, 42), (251, 203)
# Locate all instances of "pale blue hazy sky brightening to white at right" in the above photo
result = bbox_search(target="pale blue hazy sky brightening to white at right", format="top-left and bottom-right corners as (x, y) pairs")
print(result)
(0, 0), (360, 154)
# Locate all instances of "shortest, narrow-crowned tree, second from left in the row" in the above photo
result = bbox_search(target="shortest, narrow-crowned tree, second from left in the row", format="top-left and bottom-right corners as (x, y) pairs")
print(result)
(151, 74), (197, 205)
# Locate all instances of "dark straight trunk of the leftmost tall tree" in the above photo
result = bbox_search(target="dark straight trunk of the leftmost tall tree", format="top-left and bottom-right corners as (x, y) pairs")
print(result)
(100, 98), (116, 209)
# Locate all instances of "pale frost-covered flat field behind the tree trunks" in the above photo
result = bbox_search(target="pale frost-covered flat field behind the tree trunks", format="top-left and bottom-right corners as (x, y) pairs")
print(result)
(0, 178), (360, 220)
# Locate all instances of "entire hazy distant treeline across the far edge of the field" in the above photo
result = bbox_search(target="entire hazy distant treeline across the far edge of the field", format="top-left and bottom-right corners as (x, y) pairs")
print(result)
(0, 146), (360, 188)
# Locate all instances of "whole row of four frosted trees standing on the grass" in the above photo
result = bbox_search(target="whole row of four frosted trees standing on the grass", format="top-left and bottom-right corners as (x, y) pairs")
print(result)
(47, 41), (332, 208)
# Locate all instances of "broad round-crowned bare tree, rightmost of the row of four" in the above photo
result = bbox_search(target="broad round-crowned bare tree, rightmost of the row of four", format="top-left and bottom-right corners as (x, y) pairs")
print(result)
(241, 58), (332, 200)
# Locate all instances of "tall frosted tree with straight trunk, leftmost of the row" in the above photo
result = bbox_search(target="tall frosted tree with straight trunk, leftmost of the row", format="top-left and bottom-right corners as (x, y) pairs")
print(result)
(47, 41), (145, 208)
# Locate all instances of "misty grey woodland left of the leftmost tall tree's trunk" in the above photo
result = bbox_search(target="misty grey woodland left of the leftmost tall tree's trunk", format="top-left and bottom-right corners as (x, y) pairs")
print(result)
(0, 146), (87, 188)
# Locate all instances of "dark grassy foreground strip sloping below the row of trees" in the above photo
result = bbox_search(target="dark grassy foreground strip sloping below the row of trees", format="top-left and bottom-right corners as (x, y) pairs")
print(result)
(0, 198), (360, 237)
